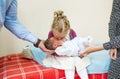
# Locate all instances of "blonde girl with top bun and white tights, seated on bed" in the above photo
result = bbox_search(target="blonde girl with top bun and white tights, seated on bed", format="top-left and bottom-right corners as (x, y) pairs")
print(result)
(43, 11), (90, 79)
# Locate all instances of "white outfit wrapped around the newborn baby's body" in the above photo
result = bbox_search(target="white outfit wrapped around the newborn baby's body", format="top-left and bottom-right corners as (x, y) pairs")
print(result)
(55, 36), (92, 56)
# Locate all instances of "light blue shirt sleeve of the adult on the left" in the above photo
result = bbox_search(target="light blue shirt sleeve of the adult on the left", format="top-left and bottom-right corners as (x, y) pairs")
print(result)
(4, 0), (37, 43)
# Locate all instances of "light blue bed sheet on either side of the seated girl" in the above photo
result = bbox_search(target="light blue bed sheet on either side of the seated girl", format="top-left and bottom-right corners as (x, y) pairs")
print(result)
(23, 42), (111, 74)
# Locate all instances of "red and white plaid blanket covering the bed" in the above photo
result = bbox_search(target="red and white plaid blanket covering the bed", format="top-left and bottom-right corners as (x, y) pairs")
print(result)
(0, 53), (107, 79)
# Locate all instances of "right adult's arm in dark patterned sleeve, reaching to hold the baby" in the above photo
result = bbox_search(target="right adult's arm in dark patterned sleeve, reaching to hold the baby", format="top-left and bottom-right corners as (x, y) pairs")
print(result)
(81, 36), (120, 56)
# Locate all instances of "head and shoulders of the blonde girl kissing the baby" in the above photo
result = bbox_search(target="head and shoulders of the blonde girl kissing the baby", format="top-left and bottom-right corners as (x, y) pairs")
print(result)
(48, 11), (76, 40)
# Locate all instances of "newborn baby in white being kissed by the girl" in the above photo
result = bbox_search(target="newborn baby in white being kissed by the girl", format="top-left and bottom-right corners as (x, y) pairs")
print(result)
(44, 36), (92, 56)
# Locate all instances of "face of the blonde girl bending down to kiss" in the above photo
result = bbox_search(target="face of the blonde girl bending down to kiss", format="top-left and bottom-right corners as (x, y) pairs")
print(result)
(52, 29), (67, 40)
